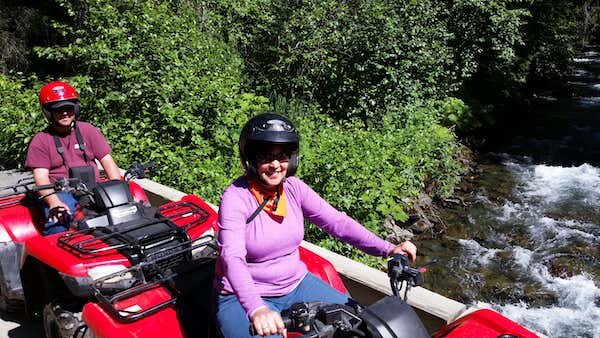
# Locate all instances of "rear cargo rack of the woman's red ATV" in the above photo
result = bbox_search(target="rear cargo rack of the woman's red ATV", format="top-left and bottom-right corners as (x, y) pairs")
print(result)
(92, 235), (216, 322)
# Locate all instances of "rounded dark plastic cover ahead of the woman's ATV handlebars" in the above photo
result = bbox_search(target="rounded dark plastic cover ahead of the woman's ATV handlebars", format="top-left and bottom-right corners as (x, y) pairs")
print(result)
(360, 296), (431, 338)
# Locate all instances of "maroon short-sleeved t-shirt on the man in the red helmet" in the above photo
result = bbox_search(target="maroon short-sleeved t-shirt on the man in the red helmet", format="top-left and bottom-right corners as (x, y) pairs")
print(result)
(25, 121), (111, 182)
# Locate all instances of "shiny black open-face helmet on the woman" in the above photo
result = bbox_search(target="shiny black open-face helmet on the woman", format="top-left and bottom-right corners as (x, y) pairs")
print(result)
(239, 113), (300, 177)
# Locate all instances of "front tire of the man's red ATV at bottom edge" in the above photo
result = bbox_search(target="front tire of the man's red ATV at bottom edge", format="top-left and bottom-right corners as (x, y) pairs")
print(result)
(43, 302), (91, 338)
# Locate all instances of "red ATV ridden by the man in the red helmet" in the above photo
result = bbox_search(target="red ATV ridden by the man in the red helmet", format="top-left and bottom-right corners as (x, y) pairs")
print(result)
(0, 165), (217, 337)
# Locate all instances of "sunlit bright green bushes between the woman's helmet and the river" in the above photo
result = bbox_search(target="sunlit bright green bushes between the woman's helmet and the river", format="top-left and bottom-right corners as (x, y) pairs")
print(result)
(276, 100), (462, 260)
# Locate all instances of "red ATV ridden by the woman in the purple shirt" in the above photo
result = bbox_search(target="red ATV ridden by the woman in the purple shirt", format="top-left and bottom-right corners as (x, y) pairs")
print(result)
(78, 232), (537, 338)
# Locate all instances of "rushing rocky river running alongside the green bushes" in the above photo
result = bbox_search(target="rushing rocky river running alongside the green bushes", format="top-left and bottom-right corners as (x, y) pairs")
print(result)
(422, 51), (600, 338)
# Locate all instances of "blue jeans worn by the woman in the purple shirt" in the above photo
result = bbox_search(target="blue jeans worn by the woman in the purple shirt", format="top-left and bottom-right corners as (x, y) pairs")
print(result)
(217, 273), (353, 338)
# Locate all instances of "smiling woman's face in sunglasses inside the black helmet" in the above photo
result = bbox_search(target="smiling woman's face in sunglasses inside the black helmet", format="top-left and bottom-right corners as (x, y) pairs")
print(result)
(256, 145), (290, 189)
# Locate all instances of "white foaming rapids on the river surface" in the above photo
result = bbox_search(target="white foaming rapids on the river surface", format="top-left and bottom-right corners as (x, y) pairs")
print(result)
(459, 160), (600, 338)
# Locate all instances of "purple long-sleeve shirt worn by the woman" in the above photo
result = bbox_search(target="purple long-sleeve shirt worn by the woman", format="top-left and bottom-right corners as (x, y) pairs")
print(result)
(215, 177), (394, 316)
